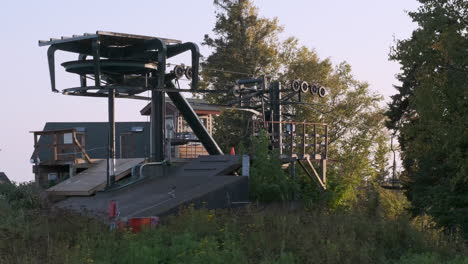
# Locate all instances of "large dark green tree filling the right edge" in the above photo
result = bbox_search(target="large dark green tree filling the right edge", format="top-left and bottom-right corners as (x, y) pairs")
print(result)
(387, 0), (468, 235)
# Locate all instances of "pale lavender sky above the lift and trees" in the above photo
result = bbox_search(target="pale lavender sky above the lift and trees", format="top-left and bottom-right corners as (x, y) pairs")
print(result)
(0, 0), (418, 182)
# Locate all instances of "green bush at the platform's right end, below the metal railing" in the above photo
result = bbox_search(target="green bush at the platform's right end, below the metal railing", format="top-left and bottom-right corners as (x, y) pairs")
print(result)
(249, 130), (297, 202)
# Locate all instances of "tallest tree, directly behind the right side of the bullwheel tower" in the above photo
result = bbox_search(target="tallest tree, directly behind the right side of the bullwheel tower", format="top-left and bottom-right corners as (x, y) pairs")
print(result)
(201, 0), (282, 151)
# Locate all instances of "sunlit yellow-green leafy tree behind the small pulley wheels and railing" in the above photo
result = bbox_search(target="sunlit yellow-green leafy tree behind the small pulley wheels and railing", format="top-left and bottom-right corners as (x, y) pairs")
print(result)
(280, 38), (389, 208)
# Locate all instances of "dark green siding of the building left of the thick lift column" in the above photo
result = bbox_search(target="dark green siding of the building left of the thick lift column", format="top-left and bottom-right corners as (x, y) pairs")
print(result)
(31, 122), (150, 163)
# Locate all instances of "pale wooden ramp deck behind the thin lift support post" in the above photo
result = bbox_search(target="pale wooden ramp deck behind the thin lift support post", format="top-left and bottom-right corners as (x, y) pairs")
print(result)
(46, 158), (144, 196)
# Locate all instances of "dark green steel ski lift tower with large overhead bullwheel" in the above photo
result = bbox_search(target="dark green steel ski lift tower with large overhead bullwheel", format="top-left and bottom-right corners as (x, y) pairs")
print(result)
(39, 31), (223, 187)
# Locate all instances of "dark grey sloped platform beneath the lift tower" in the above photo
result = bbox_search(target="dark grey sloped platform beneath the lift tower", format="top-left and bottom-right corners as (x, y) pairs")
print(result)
(56, 155), (248, 218)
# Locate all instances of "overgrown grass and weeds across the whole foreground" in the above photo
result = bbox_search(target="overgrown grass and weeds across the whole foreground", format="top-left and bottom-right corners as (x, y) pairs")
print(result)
(0, 184), (468, 264)
